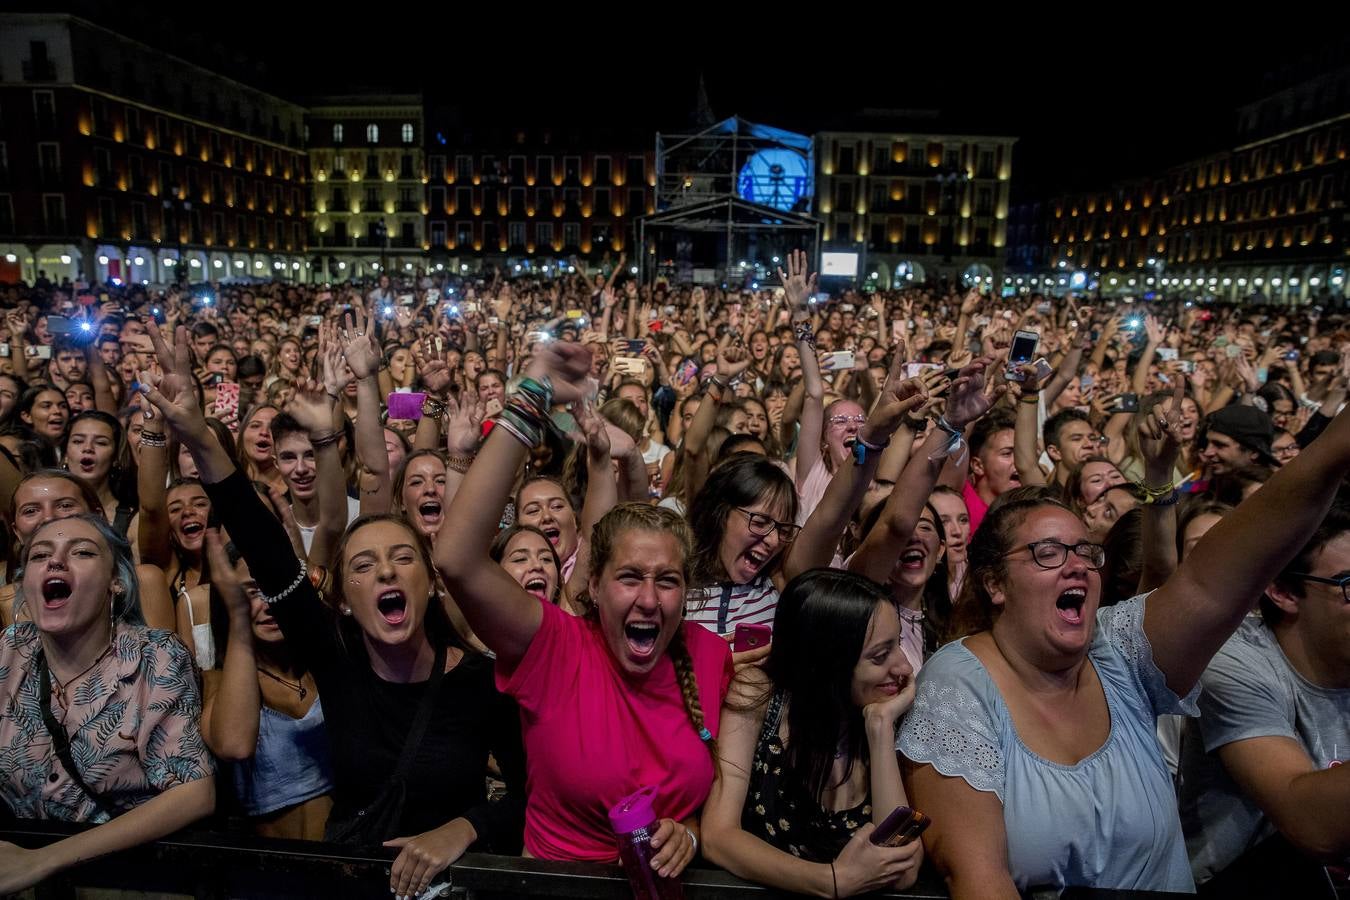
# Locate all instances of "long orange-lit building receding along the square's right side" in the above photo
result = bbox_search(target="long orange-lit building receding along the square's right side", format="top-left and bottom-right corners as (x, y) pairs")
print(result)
(1010, 67), (1350, 302)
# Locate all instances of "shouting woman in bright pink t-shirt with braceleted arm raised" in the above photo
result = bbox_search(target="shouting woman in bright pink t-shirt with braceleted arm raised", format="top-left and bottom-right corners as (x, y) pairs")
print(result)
(436, 344), (732, 876)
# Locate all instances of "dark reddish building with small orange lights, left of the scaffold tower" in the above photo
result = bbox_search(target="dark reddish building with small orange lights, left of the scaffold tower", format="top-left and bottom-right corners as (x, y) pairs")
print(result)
(427, 115), (656, 271)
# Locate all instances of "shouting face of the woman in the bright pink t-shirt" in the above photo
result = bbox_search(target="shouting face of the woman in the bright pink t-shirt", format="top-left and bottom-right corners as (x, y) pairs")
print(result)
(590, 529), (684, 676)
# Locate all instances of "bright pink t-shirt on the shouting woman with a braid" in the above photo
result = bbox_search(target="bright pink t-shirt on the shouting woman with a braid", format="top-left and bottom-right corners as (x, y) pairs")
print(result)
(497, 603), (732, 862)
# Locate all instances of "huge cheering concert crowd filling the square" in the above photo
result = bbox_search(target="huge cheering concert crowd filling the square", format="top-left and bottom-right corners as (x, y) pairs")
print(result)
(0, 252), (1350, 899)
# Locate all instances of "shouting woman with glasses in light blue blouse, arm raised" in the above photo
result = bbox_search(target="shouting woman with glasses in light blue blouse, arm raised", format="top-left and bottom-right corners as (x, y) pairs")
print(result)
(898, 402), (1350, 900)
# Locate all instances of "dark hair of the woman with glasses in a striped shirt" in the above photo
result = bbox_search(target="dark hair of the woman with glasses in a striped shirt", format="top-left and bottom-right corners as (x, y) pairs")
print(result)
(689, 453), (797, 586)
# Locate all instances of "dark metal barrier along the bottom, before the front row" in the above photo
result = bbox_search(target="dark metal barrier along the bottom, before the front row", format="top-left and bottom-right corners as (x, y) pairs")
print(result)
(0, 822), (1179, 900)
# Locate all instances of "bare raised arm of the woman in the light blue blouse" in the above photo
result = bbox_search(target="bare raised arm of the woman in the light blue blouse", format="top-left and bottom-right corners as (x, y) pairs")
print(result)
(1143, 402), (1350, 696)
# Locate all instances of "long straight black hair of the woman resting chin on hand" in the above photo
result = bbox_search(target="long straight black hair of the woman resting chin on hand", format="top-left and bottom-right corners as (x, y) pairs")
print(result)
(764, 568), (894, 797)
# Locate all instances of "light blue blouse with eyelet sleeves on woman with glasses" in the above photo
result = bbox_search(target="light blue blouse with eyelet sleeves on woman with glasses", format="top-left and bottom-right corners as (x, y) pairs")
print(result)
(896, 596), (1200, 892)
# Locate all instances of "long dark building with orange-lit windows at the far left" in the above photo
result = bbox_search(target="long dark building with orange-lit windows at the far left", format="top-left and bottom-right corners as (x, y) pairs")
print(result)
(0, 13), (306, 283)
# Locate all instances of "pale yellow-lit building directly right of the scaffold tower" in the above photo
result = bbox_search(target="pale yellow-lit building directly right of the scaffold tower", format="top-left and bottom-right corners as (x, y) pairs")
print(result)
(815, 131), (1017, 287)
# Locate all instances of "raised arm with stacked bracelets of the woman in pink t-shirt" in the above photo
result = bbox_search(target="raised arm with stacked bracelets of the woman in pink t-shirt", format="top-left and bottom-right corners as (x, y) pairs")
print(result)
(436, 343), (591, 667)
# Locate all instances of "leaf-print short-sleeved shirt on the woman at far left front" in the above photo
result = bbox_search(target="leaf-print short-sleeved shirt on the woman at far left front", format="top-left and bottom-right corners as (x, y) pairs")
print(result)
(0, 622), (215, 823)
